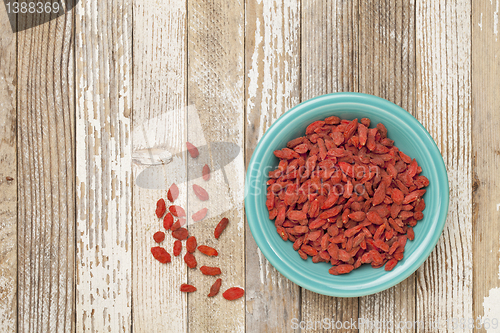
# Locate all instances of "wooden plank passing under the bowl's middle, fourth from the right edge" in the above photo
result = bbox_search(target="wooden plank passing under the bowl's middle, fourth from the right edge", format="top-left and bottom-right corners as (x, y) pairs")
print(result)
(301, 0), (359, 332)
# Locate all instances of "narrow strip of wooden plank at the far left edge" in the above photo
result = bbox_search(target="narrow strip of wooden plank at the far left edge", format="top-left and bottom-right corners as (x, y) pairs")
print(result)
(0, 6), (18, 332)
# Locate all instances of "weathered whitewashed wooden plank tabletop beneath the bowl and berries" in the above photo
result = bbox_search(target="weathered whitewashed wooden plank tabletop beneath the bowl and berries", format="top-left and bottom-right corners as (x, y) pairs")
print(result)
(0, 0), (500, 332)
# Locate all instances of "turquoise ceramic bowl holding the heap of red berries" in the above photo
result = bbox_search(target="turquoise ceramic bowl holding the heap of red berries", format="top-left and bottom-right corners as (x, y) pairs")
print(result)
(245, 93), (449, 297)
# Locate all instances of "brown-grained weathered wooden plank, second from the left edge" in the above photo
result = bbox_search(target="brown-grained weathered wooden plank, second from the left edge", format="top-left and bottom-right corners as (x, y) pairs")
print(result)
(17, 2), (75, 332)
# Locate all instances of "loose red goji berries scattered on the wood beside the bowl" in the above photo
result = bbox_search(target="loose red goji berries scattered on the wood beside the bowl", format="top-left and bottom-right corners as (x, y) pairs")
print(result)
(151, 142), (245, 300)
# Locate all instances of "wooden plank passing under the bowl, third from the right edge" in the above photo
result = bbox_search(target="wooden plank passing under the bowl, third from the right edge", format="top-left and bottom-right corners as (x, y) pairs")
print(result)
(359, 0), (416, 332)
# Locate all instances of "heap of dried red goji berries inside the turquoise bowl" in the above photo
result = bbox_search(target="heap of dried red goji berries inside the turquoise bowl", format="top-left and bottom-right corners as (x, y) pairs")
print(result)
(266, 116), (429, 275)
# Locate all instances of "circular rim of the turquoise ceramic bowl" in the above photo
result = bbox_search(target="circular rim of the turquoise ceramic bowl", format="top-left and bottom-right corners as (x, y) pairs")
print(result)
(244, 92), (449, 297)
